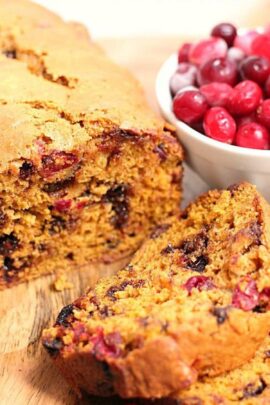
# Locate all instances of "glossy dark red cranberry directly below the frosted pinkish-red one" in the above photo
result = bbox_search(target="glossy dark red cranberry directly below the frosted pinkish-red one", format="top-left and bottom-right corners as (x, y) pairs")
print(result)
(197, 58), (237, 86)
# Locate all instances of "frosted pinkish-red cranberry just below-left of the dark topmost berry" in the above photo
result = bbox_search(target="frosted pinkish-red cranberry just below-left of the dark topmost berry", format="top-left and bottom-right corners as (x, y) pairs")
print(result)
(189, 37), (228, 65)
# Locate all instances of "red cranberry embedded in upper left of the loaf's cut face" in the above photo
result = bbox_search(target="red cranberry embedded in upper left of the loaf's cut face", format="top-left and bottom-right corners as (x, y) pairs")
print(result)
(41, 151), (79, 177)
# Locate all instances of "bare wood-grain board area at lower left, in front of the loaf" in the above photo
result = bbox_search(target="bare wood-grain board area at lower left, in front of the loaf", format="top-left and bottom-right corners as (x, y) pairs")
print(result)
(0, 262), (131, 405)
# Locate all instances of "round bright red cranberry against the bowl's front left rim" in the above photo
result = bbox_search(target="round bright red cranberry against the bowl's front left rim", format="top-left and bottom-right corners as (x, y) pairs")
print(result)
(173, 90), (208, 124)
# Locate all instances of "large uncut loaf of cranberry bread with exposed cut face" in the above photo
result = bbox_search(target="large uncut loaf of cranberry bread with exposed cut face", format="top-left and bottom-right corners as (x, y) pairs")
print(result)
(0, 0), (182, 289)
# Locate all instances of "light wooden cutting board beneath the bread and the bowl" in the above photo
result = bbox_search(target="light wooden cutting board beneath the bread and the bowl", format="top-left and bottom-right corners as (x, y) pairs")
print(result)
(0, 38), (206, 405)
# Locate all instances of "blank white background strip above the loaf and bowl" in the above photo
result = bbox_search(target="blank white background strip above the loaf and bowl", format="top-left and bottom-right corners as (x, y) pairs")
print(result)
(36, 0), (270, 38)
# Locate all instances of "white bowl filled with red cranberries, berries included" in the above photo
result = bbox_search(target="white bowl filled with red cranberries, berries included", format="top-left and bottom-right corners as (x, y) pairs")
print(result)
(156, 23), (270, 198)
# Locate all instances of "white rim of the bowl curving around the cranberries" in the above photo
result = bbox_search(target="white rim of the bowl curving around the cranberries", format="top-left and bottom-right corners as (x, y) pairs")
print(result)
(155, 52), (270, 158)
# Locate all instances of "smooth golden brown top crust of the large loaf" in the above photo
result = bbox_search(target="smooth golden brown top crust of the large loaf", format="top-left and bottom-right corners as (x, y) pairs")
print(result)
(0, 0), (173, 168)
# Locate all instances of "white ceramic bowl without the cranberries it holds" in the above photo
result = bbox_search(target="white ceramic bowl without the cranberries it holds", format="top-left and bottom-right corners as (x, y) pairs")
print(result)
(156, 54), (270, 200)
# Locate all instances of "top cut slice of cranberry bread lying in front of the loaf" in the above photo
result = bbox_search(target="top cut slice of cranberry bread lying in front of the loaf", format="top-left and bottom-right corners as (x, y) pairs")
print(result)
(43, 183), (270, 398)
